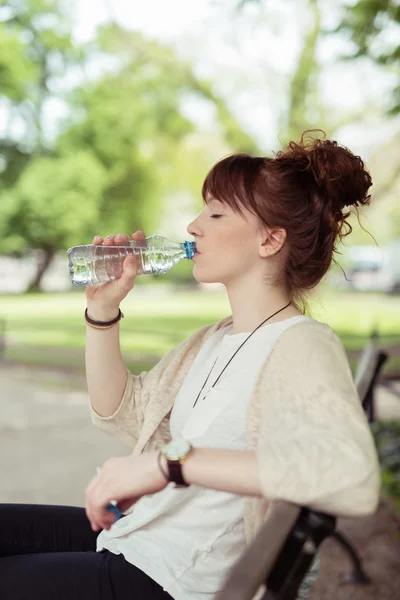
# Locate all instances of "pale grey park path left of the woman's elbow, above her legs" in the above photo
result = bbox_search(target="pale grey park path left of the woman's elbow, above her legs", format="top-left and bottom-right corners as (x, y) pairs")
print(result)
(0, 363), (129, 506)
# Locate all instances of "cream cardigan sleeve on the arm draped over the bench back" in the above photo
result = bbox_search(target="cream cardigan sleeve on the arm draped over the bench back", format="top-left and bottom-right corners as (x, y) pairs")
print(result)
(257, 323), (380, 516)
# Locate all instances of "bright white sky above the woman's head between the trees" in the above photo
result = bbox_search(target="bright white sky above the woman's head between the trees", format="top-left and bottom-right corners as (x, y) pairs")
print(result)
(67, 0), (400, 155)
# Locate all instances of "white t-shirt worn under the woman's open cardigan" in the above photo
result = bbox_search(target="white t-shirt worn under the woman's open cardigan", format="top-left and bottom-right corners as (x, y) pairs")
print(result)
(97, 315), (312, 600)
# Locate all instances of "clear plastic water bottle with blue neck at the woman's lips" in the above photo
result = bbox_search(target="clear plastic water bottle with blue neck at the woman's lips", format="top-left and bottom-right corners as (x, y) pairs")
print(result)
(67, 235), (196, 285)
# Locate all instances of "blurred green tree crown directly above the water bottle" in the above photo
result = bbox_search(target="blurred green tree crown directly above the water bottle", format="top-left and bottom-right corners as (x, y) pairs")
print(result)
(57, 26), (198, 233)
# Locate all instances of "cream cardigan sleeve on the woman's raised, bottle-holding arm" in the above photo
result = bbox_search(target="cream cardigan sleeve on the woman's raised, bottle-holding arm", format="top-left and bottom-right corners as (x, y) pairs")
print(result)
(89, 324), (218, 448)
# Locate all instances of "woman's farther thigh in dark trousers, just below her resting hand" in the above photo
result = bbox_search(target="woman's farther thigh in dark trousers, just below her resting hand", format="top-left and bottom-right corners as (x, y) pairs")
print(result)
(0, 504), (98, 557)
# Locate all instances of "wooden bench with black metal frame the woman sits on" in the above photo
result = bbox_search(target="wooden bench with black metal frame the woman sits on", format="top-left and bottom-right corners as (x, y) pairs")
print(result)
(214, 339), (388, 600)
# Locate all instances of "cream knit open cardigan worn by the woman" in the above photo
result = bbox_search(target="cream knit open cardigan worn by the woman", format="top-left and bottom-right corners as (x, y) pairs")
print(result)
(91, 316), (380, 544)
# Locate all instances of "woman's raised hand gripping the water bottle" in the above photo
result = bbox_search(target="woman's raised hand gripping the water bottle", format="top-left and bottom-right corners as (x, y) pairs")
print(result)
(86, 231), (146, 321)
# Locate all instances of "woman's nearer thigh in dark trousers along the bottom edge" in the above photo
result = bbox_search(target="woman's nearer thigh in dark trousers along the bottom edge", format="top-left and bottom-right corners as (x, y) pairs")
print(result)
(0, 551), (172, 600)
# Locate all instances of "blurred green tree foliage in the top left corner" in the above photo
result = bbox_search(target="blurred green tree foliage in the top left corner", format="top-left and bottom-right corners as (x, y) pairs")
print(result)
(0, 0), (81, 176)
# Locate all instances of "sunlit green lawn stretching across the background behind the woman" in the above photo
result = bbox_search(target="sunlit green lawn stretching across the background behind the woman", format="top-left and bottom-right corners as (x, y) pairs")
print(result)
(0, 286), (400, 372)
